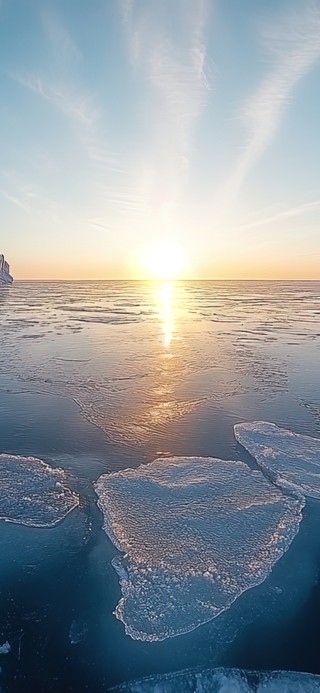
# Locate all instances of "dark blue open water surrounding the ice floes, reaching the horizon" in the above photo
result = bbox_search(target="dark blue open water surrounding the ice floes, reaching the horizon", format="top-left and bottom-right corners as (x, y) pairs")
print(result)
(0, 282), (320, 692)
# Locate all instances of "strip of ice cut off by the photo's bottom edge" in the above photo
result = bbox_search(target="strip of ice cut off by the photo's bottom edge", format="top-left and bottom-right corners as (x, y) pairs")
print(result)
(109, 669), (320, 693)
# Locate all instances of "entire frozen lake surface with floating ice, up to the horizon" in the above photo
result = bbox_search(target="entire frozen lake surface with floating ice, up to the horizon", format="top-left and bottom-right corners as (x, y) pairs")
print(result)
(0, 282), (320, 693)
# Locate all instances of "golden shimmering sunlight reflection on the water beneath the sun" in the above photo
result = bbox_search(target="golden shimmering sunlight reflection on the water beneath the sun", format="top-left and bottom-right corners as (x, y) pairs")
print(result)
(99, 281), (201, 446)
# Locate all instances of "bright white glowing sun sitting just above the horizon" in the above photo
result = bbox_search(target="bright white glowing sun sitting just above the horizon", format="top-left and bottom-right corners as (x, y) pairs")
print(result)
(143, 242), (186, 280)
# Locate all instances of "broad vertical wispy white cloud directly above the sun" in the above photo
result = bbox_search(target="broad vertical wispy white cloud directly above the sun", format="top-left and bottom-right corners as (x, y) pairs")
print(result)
(122, 0), (209, 228)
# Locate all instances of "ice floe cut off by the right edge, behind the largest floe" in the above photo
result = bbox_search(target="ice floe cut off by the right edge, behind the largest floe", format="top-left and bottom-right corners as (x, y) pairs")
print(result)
(234, 421), (320, 498)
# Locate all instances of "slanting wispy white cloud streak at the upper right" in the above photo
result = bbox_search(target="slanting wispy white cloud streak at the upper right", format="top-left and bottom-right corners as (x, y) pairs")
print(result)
(221, 1), (320, 203)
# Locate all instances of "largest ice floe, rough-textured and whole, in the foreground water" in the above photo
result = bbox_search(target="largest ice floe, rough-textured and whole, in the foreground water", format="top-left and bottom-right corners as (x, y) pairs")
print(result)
(95, 457), (304, 641)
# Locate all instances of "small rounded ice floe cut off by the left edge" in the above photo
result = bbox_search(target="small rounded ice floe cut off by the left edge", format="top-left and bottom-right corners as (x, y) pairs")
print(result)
(0, 454), (79, 527)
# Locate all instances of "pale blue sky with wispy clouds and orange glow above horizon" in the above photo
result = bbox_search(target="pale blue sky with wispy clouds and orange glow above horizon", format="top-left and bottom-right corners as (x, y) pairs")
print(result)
(0, 0), (320, 279)
